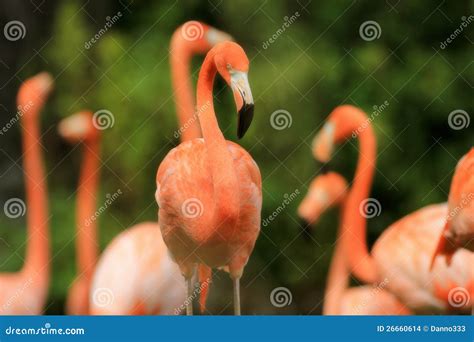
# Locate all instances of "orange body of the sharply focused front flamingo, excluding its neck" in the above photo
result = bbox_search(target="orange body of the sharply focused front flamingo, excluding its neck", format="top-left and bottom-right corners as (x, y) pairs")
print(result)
(156, 138), (262, 269)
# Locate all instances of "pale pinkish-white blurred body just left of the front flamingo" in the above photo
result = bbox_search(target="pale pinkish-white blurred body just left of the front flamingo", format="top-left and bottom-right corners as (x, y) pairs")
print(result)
(90, 222), (186, 315)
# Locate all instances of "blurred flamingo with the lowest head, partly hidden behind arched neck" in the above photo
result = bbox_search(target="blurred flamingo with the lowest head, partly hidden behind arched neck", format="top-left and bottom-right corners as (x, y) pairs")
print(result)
(298, 172), (410, 315)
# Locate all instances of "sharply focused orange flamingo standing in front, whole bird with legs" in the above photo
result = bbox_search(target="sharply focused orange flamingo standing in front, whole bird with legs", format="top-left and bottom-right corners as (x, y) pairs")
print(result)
(155, 42), (262, 315)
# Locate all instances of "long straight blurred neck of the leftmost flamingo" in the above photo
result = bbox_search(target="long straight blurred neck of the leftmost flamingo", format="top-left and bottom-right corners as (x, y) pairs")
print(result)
(22, 112), (50, 280)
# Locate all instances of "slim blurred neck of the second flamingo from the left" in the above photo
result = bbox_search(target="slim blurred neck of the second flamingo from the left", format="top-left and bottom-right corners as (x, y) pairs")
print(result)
(76, 139), (100, 281)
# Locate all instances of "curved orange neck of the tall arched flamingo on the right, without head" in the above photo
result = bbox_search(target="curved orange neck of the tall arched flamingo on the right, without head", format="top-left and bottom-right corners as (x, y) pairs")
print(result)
(342, 125), (378, 283)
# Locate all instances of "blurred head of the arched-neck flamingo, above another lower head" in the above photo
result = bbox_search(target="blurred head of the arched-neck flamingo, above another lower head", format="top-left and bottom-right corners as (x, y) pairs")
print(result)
(312, 105), (370, 163)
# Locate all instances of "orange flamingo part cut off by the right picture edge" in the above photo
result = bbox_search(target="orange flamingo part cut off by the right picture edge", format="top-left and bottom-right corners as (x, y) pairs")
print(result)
(433, 148), (474, 262)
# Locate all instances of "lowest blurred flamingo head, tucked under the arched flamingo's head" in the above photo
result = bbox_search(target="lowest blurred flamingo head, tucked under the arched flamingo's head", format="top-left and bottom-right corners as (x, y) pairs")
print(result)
(298, 172), (348, 226)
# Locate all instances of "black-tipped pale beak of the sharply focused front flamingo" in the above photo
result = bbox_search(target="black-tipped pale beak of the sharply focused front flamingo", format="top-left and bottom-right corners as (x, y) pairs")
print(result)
(230, 71), (254, 139)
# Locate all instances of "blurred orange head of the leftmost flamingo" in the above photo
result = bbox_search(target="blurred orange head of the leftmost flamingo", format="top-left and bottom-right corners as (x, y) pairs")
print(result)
(17, 72), (54, 117)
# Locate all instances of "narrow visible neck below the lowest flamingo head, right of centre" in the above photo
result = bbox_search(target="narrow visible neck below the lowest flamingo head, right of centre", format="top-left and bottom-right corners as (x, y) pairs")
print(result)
(323, 205), (350, 315)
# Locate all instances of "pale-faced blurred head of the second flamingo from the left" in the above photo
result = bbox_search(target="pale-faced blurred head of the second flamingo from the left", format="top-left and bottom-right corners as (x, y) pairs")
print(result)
(58, 111), (99, 144)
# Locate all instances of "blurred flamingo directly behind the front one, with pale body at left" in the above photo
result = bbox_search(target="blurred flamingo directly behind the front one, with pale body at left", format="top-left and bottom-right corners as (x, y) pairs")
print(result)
(89, 21), (231, 315)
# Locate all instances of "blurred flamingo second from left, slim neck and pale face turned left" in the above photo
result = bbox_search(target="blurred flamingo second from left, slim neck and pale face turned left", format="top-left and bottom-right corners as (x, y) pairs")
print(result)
(58, 111), (100, 315)
